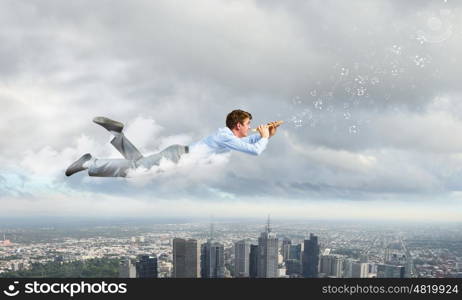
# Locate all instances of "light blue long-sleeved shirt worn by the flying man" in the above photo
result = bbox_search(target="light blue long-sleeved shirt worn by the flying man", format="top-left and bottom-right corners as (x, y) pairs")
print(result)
(189, 127), (268, 155)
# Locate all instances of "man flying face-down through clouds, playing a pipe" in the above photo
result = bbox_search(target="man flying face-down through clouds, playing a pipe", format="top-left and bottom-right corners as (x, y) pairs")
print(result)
(65, 109), (283, 177)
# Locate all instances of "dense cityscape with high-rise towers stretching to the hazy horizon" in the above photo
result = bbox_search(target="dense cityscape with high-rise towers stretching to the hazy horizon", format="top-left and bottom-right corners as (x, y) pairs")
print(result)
(0, 218), (462, 278)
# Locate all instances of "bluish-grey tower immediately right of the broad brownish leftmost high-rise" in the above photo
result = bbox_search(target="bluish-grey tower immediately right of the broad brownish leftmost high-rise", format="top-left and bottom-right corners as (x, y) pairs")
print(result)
(201, 239), (225, 278)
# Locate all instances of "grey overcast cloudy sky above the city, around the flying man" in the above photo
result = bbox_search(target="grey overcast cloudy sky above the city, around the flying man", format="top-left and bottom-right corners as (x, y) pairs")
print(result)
(0, 0), (462, 221)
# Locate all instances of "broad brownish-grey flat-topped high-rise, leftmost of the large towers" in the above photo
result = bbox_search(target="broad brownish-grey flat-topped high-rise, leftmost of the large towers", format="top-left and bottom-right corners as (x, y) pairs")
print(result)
(172, 238), (200, 278)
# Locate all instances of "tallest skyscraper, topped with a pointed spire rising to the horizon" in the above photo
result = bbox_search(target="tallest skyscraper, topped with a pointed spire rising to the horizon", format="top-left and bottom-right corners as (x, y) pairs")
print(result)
(257, 218), (279, 278)
